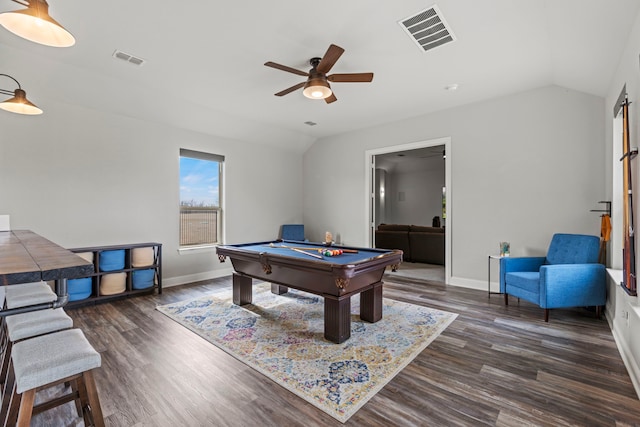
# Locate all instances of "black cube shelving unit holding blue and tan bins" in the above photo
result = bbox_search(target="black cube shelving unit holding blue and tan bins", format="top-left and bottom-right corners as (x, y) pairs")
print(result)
(67, 243), (162, 307)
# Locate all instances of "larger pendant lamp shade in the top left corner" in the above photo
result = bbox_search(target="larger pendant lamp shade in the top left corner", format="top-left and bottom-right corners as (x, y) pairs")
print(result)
(0, 0), (76, 47)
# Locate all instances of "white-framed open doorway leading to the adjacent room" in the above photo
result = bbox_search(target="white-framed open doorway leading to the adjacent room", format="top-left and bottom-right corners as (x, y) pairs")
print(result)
(365, 137), (453, 283)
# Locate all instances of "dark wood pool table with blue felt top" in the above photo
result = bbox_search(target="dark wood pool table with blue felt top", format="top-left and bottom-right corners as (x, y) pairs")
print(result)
(217, 240), (402, 344)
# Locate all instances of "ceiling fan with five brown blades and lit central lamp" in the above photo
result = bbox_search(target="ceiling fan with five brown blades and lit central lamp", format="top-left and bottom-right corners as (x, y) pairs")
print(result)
(264, 44), (373, 104)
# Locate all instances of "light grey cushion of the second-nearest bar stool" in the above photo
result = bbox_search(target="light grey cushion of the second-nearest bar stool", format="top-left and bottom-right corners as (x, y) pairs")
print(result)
(5, 308), (73, 342)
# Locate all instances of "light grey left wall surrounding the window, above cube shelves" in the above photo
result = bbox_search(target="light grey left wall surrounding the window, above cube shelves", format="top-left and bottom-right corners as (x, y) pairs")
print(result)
(0, 102), (302, 285)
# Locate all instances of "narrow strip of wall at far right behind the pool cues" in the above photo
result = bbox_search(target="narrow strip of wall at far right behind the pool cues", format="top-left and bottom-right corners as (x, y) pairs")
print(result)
(605, 8), (640, 395)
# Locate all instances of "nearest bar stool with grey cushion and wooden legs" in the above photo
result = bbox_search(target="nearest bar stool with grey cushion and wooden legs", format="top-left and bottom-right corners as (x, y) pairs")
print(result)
(5, 329), (104, 427)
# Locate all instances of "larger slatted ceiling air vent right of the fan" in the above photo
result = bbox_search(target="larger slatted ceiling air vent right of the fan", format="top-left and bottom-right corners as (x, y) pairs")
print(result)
(398, 5), (456, 52)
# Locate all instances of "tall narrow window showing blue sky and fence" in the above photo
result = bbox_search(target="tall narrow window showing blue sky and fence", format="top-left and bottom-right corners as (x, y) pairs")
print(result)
(180, 148), (224, 248)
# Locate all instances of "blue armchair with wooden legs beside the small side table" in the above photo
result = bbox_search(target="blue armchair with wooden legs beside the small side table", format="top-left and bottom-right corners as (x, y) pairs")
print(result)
(500, 234), (607, 322)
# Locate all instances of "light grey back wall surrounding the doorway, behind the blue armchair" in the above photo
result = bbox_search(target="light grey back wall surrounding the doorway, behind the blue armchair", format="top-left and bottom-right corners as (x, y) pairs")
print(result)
(303, 86), (606, 289)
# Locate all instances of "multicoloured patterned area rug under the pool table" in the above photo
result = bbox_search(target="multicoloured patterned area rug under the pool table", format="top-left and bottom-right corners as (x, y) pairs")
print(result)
(156, 283), (457, 423)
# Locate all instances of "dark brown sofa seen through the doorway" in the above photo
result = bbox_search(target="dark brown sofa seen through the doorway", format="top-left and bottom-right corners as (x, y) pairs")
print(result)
(376, 224), (444, 265)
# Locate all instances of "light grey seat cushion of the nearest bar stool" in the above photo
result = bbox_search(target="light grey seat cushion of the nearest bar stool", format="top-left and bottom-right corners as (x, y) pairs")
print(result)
(11, 329), (102, 393)
